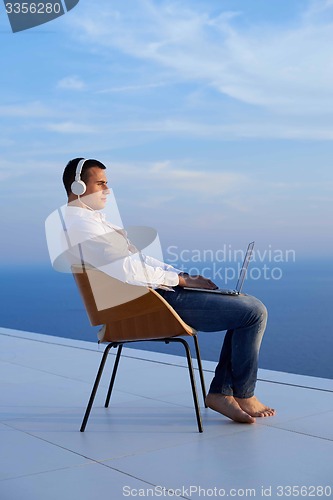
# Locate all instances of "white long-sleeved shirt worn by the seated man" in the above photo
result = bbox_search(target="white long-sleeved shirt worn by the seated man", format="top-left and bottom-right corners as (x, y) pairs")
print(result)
(63, 206), (181, 288)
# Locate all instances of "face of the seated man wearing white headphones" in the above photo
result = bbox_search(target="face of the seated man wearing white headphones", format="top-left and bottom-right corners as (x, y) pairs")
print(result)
(83, 167), (110, 210)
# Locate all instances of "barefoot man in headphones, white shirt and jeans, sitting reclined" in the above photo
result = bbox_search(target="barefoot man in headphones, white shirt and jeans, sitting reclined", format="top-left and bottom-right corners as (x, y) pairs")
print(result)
(63, 158), (275, 423)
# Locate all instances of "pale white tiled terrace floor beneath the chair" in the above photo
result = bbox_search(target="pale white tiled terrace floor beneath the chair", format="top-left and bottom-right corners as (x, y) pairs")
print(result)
(0, 328), (333, 500)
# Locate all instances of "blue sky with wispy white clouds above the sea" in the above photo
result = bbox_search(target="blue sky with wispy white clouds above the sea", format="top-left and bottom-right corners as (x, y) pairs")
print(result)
(0, 0), (333, 265)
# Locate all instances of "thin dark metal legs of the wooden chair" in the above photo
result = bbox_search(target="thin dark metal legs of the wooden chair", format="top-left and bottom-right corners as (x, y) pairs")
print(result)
(80, 334), (207, 432)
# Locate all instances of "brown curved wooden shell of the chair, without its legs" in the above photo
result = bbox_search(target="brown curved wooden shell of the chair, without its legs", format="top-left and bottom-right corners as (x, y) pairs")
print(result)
(72, 266), (195, 342)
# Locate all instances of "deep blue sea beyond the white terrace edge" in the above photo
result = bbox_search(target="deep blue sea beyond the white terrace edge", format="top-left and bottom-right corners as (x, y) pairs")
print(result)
(0, 259), (333, 379)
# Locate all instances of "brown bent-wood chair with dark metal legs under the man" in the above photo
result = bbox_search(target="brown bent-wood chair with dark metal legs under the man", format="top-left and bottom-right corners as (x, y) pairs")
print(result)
(72, 266), (206, 432)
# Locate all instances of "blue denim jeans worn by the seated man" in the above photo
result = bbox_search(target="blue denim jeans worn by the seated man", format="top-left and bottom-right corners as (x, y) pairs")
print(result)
(157, 286), (267, 398)
